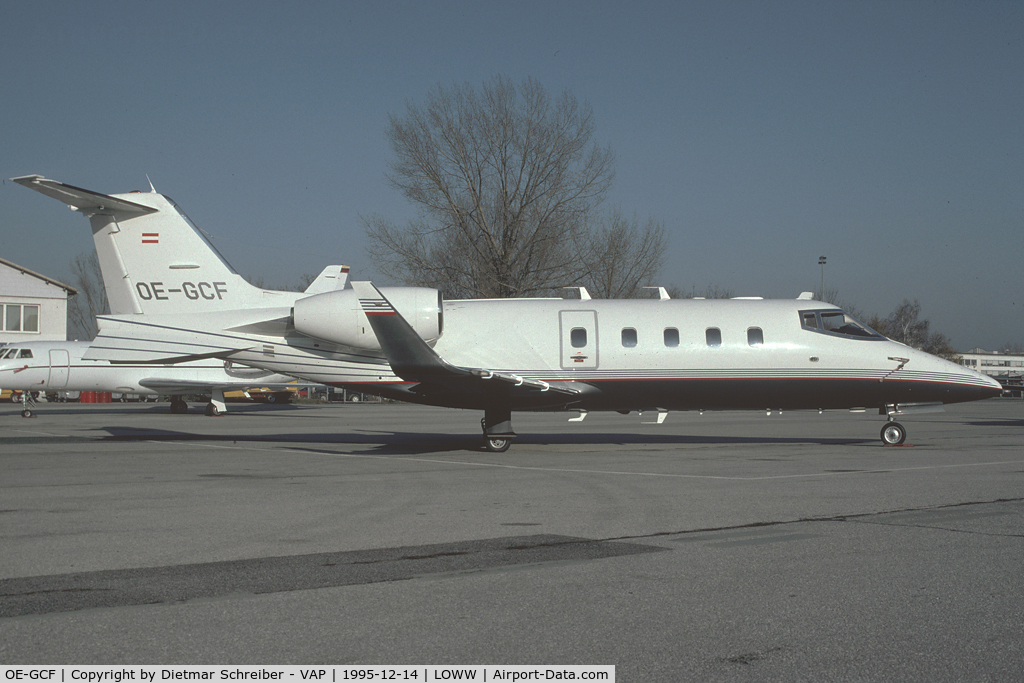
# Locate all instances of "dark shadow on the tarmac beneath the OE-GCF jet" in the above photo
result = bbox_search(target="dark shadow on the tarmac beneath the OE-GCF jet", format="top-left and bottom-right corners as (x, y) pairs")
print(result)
(83, 426), (878, 455)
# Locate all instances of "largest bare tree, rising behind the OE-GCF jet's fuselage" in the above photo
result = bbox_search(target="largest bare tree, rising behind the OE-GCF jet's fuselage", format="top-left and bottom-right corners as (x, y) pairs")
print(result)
(364, 77), (638, 297)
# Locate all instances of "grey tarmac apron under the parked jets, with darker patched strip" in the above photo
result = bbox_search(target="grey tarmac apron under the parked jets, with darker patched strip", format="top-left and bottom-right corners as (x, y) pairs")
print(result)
(0, 398), (1024, 682)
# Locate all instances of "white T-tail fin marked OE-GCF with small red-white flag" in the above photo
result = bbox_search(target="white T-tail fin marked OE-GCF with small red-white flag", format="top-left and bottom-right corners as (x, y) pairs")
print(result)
(11, 175), (276, 315)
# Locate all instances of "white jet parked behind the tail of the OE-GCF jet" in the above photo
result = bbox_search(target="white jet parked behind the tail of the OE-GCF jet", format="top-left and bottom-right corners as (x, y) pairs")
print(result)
(0, 341), (295, 418)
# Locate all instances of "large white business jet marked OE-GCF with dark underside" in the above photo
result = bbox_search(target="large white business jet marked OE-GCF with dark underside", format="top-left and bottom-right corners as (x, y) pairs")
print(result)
(13, 176), (999, 452)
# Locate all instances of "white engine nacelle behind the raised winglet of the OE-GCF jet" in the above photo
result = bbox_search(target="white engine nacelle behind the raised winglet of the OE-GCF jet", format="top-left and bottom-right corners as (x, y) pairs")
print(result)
(292, 287), (444, 351)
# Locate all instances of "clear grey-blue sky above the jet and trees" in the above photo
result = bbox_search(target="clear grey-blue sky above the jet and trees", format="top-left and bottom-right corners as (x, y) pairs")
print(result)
(0, 0), (1024, 349)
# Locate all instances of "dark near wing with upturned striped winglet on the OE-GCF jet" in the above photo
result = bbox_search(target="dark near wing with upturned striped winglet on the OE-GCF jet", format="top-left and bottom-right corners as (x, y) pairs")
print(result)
(352, 282), (589, 405)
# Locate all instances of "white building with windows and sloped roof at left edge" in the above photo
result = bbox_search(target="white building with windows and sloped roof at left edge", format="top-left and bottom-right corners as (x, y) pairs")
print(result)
(0, 258), (78, 343)
